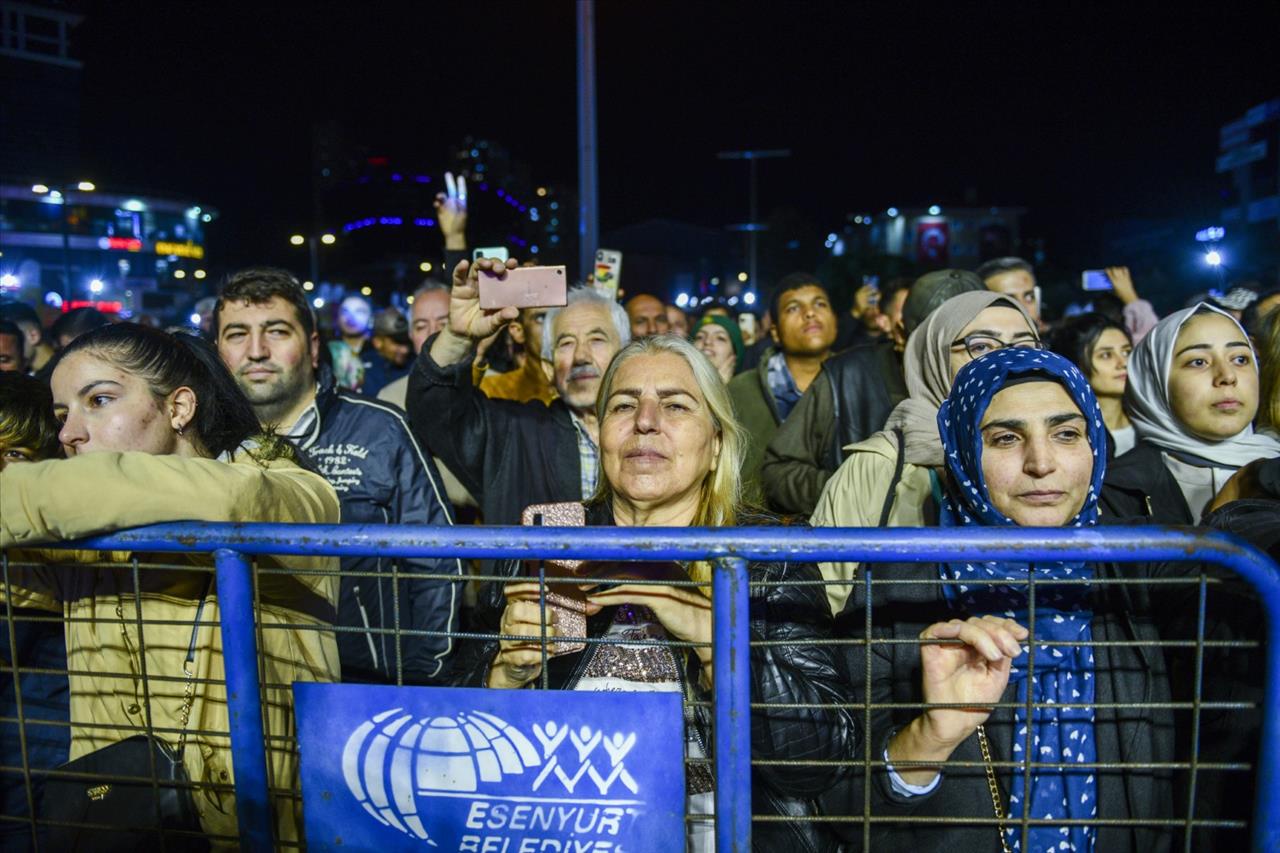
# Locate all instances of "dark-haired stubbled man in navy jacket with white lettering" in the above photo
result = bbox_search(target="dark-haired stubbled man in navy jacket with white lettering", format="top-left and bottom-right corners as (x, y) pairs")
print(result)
(214, 268), (462, 684)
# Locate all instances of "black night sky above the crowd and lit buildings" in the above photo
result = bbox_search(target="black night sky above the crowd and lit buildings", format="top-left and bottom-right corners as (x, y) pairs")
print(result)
(77, 0), (1280, 272)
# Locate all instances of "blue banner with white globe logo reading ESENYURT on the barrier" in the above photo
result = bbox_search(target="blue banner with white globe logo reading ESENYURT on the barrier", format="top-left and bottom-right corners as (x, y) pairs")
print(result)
(293, 683), (685, 853)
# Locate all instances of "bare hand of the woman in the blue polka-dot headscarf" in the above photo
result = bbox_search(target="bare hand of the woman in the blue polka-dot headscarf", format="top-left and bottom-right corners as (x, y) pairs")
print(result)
(888, 616), (1028, 785)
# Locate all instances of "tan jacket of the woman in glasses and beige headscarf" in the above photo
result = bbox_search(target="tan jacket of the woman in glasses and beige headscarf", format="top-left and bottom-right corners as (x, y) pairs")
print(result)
(809, 432), (932, 615)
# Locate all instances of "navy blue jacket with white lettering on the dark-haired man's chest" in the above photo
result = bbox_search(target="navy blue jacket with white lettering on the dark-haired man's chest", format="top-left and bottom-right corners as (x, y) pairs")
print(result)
(291, 368), (465, 684)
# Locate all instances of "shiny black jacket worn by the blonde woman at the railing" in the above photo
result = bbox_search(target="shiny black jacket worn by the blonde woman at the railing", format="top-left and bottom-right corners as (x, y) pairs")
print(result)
(456, 507), (859, 853)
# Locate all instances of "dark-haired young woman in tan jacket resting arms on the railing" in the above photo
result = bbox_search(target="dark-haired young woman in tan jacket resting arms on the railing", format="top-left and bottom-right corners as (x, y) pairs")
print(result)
(0, 324), (339, 841)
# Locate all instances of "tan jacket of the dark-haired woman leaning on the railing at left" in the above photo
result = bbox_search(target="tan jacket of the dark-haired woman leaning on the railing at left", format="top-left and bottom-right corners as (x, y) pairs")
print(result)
(0, 452), (340, 840)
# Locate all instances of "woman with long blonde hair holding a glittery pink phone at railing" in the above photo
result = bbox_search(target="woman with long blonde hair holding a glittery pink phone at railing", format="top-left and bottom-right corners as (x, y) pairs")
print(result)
(460, 336), (856, 850)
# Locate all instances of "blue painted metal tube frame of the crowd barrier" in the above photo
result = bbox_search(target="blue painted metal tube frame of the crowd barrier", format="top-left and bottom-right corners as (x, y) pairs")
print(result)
(2, 523), (1280, 850)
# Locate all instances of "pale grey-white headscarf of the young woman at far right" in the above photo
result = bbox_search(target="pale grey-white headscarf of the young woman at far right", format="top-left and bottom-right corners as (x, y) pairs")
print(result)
(1124, 302), (1280, 467)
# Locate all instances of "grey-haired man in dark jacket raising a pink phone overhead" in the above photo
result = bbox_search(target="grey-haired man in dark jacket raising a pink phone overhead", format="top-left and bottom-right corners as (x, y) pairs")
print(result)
(407, 259), (631, 524)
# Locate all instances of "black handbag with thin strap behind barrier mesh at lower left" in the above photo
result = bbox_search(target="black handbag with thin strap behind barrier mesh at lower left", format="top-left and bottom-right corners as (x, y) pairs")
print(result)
(40, 597), (209, 853)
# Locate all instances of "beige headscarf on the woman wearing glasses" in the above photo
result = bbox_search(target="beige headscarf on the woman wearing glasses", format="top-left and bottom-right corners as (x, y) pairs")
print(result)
(884, 291), (1036, 467)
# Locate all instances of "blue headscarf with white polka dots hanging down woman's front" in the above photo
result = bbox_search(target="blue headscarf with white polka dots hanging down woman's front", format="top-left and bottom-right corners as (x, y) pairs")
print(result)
(938, 348), (1107, 852)
